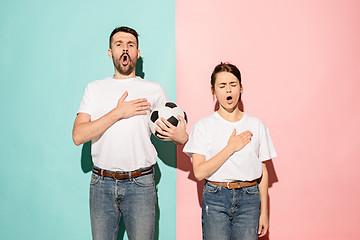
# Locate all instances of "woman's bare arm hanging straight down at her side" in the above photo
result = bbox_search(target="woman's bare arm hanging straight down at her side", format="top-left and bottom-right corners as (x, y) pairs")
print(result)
(258, 163), (269, 237)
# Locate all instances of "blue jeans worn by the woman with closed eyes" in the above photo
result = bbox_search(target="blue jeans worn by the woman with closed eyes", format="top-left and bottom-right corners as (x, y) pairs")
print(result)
(202, 182), (260, 240)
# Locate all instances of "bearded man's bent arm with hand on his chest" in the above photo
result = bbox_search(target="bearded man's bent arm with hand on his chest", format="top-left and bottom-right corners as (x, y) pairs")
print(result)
(72, 91), (150, 145)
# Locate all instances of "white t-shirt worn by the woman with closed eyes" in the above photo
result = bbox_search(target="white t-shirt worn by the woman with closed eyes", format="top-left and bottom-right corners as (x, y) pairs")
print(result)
(183, 112), (277, 182)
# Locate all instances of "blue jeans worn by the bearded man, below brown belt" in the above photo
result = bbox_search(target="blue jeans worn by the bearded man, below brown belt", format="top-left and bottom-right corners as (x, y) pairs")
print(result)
(90, 167), (156, 240)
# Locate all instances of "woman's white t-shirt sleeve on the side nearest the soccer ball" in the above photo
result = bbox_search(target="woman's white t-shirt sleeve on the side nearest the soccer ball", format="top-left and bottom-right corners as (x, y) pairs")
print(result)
(183, 122), (206, 157)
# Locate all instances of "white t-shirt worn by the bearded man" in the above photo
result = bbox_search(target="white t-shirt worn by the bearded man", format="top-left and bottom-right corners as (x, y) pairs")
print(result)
(78, 77), (168, 171)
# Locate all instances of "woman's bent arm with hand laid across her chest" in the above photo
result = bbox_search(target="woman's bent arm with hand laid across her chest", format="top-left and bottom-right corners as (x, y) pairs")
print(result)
(192, 129), (252, 181)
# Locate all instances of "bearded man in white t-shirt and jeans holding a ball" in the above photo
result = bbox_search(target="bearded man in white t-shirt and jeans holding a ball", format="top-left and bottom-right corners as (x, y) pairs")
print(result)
(73, 27), (188, 240)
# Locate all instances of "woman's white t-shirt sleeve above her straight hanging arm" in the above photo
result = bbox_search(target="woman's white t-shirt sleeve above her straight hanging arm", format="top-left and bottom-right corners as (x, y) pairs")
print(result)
(259, 124), (277, 162)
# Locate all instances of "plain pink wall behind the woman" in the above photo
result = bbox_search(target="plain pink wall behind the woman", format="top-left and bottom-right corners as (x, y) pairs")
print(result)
(176, 0), (360, 240)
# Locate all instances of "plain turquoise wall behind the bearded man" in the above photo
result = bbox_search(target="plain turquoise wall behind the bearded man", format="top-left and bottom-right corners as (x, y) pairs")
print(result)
(0, 0), (176, 239)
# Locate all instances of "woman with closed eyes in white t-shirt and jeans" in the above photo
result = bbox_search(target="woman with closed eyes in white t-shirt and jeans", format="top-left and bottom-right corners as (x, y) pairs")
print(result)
(183, 63), (276, 240)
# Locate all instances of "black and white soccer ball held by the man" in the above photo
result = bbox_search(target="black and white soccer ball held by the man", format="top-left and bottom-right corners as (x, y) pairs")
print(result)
(149, 102), (187, 141)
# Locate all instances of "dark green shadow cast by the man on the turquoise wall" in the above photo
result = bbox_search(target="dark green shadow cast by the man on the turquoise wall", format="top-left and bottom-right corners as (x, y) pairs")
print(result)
(81, 57), (177, 240)
